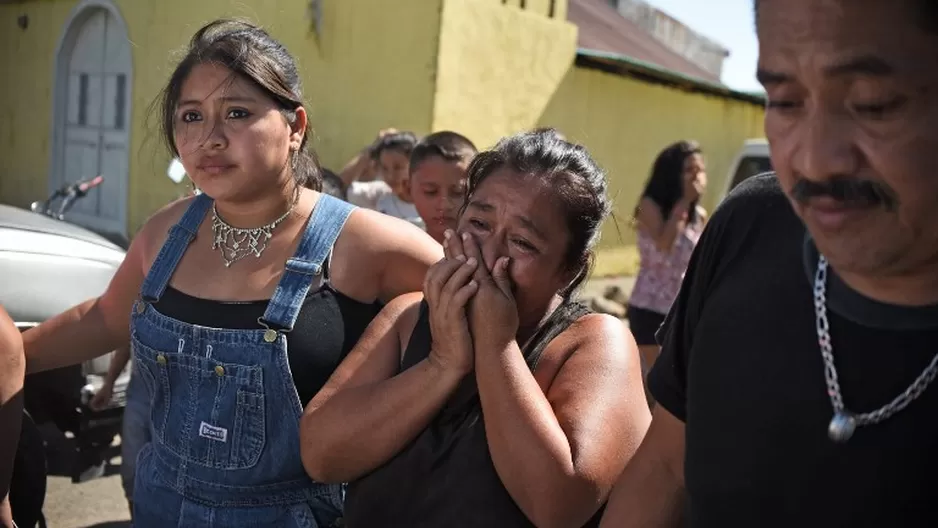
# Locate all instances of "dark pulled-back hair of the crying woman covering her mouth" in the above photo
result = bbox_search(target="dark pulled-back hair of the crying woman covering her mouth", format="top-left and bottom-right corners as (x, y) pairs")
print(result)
(463, 128), (611, 298)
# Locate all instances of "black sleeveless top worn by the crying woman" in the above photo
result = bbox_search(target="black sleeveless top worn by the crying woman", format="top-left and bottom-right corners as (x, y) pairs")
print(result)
(345, 302), (602, 528)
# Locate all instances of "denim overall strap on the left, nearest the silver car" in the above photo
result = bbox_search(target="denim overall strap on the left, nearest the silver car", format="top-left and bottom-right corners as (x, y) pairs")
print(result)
(140, 194), (212, 303)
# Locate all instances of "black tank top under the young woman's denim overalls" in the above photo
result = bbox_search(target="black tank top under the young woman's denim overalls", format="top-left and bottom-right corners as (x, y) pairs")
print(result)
(153, 261), (381, 407)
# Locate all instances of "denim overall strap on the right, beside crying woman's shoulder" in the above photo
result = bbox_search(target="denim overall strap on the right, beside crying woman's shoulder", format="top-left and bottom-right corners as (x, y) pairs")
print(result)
(258, 193), (355, 332)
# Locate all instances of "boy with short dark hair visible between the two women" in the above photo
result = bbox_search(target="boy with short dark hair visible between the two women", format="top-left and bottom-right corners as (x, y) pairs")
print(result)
(409, 131), (478, 244)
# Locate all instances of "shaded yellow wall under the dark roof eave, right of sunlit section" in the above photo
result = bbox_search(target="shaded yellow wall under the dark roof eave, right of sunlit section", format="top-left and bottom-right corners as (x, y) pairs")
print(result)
(539, 67), (764, 276)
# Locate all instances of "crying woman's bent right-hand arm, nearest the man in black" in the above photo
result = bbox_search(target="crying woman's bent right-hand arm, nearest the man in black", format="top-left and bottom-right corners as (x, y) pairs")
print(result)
(473, 315), (650, 526)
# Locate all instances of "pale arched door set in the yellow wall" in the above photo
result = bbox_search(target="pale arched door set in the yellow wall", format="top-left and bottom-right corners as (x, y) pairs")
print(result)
(49, 0), (132, 236)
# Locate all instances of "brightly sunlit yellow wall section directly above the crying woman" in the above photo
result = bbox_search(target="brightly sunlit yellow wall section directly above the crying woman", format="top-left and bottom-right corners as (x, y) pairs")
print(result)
(433, 0), (577, 147)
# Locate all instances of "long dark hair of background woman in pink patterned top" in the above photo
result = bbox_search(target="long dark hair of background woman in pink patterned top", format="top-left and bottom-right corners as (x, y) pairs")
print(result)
(635, 141), (701, 224)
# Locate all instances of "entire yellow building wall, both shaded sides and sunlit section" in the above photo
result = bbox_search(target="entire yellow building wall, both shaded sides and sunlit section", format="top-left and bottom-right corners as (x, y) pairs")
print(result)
(0, 0), (763, 275)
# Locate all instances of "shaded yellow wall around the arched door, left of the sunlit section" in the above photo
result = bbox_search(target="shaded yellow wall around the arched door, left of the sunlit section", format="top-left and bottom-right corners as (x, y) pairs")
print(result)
(0, 0), (441, 233)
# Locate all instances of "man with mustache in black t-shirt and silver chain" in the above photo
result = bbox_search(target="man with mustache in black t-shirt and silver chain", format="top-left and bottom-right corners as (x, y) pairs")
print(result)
(603, 0), (938, 528)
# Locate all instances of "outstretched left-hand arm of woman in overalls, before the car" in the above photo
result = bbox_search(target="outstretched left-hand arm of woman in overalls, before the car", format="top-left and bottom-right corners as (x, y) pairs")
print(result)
(23, 217), (147, 373)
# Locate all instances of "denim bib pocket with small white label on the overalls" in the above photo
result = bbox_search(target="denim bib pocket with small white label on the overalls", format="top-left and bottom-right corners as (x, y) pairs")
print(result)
(132, 334), (267, 470)
